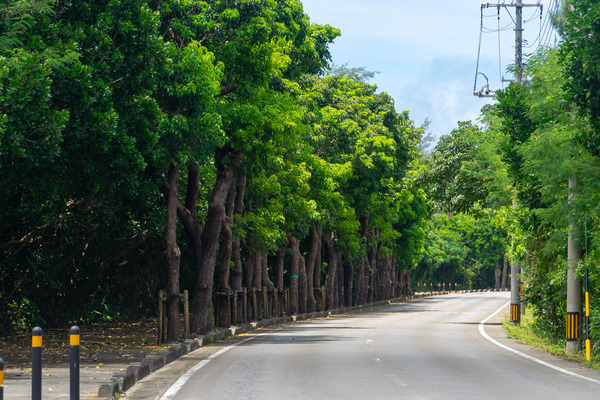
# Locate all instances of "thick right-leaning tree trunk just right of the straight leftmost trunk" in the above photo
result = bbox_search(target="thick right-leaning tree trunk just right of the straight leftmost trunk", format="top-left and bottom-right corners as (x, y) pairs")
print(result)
(190, 152), (242, 333)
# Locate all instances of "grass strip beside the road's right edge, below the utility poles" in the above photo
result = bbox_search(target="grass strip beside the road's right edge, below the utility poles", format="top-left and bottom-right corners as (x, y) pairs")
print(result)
(504, 309), (600, 370)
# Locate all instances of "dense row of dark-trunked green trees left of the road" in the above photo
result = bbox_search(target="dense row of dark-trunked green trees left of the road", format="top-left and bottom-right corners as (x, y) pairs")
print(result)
(0, 0), (428, 338)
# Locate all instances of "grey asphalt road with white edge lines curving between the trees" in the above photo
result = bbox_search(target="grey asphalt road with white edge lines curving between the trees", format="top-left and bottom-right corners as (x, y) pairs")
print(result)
(137, 292), (600, 400)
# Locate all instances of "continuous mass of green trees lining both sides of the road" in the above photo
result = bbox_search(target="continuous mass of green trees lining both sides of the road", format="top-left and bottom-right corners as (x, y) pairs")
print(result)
(0, 0), (600, 364)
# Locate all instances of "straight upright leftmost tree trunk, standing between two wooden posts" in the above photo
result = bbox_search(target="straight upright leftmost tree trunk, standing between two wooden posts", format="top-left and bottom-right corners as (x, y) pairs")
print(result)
(165, 165), (181, 341)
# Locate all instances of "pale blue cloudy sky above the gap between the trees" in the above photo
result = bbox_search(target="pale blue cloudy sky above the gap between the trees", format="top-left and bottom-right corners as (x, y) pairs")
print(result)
(301, 0), (556, 147)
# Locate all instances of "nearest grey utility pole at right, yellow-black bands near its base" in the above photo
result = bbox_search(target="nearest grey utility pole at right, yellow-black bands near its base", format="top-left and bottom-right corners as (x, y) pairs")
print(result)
(566, 175), (581, 354)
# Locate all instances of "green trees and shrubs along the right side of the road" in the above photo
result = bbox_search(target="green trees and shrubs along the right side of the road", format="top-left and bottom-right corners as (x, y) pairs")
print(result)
(421, 0), (600, 355)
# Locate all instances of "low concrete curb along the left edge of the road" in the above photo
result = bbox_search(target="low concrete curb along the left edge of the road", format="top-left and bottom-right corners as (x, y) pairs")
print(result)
(98, 289), (510, 400)
